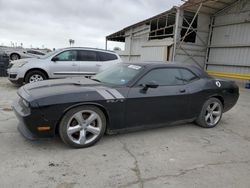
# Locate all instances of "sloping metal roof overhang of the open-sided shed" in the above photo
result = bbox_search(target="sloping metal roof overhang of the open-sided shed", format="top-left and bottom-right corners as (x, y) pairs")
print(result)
(106, 0), (241, 42)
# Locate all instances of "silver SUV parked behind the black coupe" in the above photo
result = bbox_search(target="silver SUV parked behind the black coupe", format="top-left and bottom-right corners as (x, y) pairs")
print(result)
(7, 47), (122, 84)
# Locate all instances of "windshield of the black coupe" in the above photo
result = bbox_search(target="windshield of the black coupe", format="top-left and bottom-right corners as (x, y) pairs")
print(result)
(92, 64), (142, 85)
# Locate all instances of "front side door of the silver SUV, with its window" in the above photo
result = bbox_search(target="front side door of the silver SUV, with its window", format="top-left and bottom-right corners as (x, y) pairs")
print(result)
(50, 50), (79, 78)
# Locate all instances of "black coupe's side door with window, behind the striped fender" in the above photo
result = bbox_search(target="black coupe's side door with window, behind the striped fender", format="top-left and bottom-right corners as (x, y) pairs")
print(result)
(125, 68), (188, 127)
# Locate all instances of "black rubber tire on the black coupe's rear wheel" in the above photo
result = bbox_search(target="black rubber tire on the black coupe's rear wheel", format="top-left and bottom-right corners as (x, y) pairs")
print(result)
(195, 98), (223, 128)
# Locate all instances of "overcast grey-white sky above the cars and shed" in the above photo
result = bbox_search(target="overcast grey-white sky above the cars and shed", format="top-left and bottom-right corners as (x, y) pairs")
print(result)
(0, 0), (181, 49)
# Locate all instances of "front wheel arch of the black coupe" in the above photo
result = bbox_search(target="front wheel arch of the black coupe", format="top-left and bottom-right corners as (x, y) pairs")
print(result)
(55, 102), (110, 134)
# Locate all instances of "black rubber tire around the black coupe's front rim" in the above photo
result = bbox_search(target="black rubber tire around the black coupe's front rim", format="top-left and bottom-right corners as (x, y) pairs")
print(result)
(59, 105), (106, 148)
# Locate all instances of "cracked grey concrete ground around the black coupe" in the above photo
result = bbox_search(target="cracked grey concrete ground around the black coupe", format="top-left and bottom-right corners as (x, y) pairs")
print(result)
(0, 78), (250, 188)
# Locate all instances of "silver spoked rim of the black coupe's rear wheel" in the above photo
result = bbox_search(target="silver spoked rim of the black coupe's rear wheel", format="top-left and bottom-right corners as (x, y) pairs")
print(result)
(205, 102), (222, 126)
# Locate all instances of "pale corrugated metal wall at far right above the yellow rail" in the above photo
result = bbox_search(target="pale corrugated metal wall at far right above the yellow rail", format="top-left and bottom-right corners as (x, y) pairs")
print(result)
(207, 1), (250, 74)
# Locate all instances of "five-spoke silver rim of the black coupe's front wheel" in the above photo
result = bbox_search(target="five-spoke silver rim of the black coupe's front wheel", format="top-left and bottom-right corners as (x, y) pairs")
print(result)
(67, 110), (102, 145)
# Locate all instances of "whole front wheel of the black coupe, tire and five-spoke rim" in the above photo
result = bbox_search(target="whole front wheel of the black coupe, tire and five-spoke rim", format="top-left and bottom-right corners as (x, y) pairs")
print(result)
(59, 106), (106, 148)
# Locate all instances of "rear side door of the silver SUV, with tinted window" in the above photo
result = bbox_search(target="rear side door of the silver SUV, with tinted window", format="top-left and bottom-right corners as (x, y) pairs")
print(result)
(77, 50), (99, 76)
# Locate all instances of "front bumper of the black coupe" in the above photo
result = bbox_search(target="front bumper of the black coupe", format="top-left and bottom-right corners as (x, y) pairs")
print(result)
(12, 98), (55, 141)
